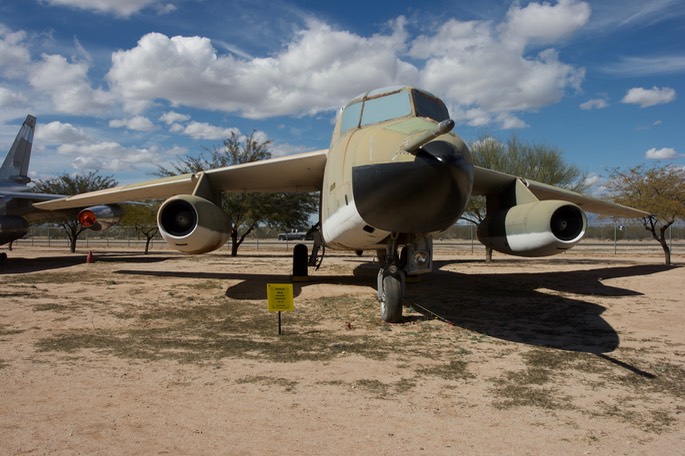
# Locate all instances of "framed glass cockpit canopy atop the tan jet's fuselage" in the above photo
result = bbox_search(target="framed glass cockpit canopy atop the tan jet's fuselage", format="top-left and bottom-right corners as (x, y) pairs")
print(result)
(340, 87), (449, 135)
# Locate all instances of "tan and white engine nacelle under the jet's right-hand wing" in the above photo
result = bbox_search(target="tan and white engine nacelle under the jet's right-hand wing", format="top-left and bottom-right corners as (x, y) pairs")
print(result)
(478, 200), (587, 257)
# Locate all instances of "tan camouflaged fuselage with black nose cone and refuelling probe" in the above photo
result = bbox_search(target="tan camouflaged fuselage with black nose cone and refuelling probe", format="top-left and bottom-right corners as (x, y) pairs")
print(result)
(321, 87), (473, 250)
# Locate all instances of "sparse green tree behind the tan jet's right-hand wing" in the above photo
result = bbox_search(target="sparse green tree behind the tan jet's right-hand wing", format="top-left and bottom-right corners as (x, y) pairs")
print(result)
(462, 136), (587, 262)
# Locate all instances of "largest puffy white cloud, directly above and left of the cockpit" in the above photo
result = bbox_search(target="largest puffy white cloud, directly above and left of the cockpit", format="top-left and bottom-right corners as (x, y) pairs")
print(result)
(107, 20), (417, 118)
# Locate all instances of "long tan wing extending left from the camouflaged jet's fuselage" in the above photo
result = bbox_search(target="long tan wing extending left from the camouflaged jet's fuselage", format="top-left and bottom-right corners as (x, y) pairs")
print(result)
(34, 149), (328, 210)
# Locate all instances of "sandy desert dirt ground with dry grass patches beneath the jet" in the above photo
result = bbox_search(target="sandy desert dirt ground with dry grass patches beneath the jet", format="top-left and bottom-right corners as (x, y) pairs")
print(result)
(0, 240), (685, 455)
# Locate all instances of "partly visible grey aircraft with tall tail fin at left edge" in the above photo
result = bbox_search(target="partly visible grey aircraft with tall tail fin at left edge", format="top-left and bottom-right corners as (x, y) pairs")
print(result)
(0, 114), (123, 261)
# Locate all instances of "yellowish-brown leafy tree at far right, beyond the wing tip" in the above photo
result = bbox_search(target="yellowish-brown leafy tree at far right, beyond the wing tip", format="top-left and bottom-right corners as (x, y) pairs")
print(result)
(607, 165), (685, 265)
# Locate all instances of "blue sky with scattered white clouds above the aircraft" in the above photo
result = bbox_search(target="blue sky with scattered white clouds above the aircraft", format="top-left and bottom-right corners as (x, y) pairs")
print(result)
(0, 0), (685, 188)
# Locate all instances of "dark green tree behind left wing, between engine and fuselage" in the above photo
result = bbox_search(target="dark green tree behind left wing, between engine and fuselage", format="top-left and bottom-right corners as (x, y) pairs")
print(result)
(155, 131), (318, 256)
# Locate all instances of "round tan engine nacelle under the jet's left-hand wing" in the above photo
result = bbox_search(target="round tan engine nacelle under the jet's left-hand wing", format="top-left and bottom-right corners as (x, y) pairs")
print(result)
(157, 195), (231, 253)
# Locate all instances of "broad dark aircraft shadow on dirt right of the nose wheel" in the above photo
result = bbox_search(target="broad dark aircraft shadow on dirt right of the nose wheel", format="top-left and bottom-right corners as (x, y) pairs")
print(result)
(406, 263), (668, 356)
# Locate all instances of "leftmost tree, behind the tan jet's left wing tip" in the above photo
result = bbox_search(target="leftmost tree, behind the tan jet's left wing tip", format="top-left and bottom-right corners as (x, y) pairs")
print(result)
(33, 171), (117, 253)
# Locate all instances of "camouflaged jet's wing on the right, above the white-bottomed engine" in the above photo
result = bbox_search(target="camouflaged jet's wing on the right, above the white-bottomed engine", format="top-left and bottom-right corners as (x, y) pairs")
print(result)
(473, 166), (650, 218)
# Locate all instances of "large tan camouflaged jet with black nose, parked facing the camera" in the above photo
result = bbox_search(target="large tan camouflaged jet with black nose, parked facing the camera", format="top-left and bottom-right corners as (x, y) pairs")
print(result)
(36, 87), (649, 322)
